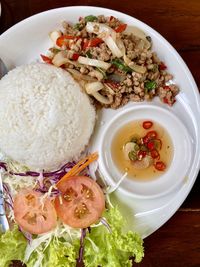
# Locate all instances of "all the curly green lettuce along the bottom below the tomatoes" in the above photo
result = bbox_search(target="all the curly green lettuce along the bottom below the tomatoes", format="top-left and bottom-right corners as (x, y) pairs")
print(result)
(0, 207), (144, 267)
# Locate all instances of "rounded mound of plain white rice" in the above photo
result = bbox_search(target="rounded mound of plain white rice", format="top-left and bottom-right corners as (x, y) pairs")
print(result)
(0, 63), (95, 170)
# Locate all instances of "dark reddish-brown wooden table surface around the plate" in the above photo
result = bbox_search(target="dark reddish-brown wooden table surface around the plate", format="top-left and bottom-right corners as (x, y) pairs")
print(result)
(0, 0), (200, 267)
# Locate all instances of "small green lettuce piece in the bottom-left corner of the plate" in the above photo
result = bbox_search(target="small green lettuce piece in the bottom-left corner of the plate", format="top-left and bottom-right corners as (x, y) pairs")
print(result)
(0, 226), (27, 267)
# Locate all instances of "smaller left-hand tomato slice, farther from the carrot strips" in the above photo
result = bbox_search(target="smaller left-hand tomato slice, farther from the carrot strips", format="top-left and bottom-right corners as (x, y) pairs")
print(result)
(14, 189), (57, 235)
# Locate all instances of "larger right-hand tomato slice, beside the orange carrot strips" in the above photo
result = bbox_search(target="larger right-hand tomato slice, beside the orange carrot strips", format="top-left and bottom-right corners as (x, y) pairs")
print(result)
(55, 176), (105, 228)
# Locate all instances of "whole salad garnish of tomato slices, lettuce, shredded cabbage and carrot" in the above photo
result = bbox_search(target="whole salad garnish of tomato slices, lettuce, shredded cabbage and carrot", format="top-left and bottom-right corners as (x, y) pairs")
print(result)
(0, 153), (144, 267)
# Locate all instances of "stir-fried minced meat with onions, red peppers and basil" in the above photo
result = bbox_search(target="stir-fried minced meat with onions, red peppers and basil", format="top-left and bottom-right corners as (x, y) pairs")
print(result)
(42, 15), (179, 109)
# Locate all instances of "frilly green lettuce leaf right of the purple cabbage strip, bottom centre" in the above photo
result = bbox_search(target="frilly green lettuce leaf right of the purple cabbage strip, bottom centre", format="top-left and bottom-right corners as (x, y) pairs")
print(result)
(84, 207), (144, 267)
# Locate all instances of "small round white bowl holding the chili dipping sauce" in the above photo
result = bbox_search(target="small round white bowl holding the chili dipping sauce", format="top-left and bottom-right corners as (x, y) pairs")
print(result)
(99, 104), (192, 198)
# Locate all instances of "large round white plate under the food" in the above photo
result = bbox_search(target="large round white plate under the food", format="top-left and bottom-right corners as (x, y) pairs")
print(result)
(0, 6), (200, 237)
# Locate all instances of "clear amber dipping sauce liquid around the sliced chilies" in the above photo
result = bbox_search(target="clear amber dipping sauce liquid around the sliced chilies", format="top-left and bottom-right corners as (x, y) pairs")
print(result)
(111, 120), (174, 180)
